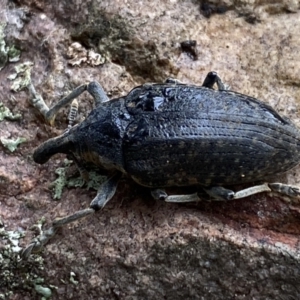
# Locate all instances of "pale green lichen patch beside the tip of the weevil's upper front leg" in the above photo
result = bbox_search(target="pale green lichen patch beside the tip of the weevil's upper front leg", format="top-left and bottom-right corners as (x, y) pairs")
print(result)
(7, 61), (33, 92)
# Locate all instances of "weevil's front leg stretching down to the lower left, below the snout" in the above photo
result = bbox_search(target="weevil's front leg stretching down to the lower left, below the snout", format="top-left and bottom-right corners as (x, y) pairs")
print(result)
(21, 173), (120, 259)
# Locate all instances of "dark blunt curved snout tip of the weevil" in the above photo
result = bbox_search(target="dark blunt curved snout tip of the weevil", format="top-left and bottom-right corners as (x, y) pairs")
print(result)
(33, 135), (73, 164)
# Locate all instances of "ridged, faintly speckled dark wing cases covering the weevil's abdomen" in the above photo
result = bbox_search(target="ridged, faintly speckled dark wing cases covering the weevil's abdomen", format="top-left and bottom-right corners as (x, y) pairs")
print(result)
(123, 85), (300, 187)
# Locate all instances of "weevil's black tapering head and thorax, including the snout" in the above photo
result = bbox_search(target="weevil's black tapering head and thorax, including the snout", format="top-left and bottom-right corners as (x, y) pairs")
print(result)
(33, 101), (128, 170)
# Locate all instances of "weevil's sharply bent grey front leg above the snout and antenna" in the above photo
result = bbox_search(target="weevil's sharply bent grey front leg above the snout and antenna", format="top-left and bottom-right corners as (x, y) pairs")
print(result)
(28, 81), (109, 125)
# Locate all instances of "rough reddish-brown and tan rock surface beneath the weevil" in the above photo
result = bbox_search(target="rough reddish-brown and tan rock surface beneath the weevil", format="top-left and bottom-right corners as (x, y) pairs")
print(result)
(0, 0), (300, 299)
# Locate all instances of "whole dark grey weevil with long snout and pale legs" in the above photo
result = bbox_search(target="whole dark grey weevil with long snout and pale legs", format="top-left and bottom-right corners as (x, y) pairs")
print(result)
(22, 72), (300, 257)
